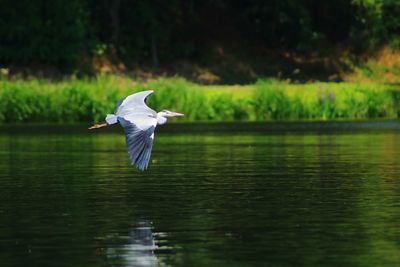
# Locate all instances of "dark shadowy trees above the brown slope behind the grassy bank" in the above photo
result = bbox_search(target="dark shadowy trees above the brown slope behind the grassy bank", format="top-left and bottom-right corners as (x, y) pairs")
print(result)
(0, 0), (400, 72)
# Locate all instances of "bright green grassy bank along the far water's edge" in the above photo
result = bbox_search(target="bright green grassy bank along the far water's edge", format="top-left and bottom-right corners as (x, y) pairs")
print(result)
(0, 76), (400, 123)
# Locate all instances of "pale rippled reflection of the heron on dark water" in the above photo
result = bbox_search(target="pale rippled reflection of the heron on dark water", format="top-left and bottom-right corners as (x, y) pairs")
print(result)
(106, 221), (161, 267)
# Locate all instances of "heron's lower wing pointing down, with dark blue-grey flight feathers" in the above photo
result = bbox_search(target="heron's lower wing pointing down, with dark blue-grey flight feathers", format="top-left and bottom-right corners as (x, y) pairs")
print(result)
(118, 117), (157, 171)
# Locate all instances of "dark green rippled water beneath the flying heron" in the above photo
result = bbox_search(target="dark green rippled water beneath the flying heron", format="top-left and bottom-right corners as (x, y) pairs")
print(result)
(0, 122), (400, 267)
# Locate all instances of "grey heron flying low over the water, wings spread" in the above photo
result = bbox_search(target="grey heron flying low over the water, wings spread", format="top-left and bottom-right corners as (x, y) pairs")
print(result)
(89, 90), (183, 171)
